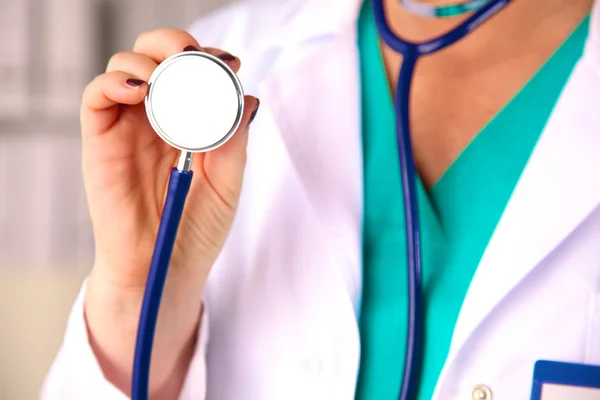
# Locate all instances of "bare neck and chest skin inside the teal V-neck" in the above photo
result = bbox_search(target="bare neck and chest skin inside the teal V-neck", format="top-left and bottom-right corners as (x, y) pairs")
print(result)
(382, 0), (593, 187)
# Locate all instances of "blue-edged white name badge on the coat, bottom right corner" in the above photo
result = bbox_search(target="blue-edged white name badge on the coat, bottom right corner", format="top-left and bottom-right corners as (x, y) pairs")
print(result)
(531, 360), (600, 400)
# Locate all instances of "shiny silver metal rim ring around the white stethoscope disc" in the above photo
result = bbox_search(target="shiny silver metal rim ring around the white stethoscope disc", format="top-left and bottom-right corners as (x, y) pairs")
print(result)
(144, 51), (244, 153)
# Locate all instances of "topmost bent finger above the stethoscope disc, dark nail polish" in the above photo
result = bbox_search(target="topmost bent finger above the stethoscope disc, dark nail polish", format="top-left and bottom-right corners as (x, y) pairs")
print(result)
(133, 28), (201, 64)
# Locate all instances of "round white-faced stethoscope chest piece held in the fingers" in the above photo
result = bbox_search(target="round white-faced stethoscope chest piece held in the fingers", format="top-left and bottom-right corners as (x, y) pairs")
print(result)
(145, 51), (244, 152)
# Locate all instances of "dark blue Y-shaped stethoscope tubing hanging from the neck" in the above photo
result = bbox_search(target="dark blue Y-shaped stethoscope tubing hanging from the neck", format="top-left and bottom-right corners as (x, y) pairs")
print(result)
(372, 0), (511, 400)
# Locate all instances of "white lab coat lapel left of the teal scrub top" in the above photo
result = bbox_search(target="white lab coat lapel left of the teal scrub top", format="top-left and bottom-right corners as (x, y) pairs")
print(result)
(260, 0), (362, 312)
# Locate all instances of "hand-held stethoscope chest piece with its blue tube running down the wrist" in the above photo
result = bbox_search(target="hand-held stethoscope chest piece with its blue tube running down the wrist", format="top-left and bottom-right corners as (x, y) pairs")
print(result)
(131, 51), (244, 400)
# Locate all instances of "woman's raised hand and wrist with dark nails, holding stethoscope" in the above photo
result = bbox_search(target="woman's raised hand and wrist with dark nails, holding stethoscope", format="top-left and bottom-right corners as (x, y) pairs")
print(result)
(81, 29), (259, 399)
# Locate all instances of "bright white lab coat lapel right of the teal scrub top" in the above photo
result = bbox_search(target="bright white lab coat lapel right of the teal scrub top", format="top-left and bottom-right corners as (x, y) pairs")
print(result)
(446, 11), (600, 366)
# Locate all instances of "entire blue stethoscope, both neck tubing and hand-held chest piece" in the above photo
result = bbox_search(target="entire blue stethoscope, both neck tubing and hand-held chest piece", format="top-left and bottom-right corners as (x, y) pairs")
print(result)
(132, 0), (511, 400)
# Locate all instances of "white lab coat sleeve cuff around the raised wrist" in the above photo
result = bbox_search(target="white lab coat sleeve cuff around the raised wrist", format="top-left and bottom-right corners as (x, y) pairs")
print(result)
(40, 283), (208, 400)
